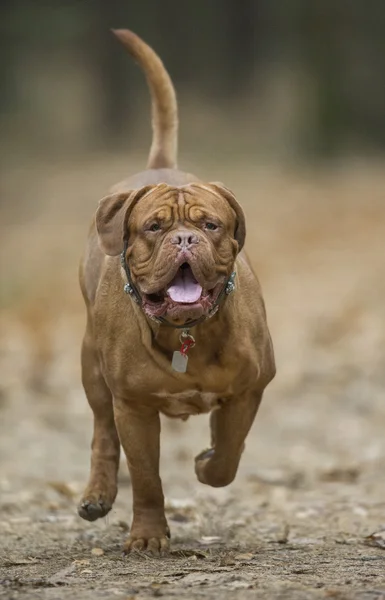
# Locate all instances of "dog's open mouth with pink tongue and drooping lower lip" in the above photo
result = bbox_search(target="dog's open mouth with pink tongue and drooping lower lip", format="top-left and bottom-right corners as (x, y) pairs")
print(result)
(143, 262), (221, 318)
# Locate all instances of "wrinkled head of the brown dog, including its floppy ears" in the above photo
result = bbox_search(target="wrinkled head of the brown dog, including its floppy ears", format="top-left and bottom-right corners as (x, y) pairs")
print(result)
(96, 184), (245, 323)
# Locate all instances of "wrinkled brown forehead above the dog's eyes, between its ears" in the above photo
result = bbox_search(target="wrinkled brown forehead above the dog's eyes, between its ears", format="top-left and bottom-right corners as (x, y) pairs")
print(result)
(131, 184), (233, 221)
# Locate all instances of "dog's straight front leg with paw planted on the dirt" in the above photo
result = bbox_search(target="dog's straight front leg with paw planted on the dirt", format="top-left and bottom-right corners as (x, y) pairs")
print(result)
(114, 400), (170, 554)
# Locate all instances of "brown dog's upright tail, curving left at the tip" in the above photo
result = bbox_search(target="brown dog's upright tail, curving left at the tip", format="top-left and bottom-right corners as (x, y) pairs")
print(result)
(112, 29), (178, 169)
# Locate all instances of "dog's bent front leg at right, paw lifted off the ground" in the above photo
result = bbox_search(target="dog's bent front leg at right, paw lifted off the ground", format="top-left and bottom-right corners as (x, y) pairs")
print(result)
(195, 392), (262, 487)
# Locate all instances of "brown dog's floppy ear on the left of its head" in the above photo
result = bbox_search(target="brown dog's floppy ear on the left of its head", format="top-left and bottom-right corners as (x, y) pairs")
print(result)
(95, 185), (153, 256)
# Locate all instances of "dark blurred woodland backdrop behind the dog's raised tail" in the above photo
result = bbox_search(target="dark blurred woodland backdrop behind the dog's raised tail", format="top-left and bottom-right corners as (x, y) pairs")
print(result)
(0, 0), (385, 161)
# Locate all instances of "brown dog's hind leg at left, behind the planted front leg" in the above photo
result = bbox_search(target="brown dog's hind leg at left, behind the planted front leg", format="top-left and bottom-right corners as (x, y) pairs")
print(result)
(78, 329), (120, 521)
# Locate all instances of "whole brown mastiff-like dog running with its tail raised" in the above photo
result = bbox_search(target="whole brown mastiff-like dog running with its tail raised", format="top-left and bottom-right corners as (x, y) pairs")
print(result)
(79, 30), (275, 554)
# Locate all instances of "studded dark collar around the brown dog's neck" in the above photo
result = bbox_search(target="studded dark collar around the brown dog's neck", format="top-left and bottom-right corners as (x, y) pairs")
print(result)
(120, 241), (236, 331)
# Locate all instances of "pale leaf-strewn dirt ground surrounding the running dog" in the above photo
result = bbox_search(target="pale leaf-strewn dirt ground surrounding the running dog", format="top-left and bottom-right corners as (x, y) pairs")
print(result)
(0, 166), (385, 600)
